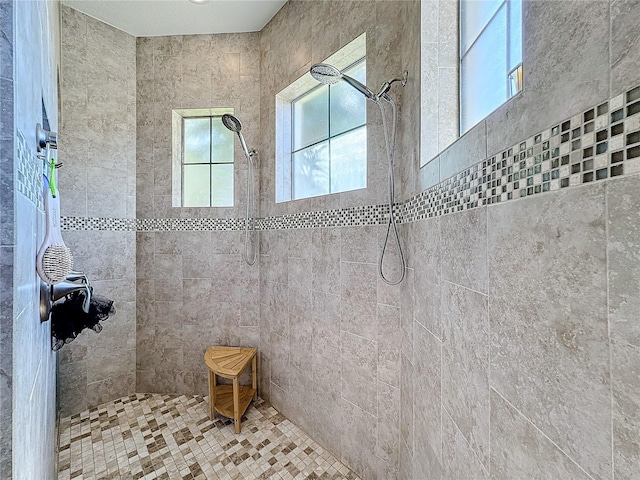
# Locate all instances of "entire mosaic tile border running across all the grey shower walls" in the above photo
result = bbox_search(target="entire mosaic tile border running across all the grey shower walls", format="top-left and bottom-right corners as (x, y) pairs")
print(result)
(62, 86), (640, 231)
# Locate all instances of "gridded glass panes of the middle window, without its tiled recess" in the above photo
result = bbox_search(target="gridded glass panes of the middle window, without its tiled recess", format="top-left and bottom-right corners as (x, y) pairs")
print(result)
(291, 58), (367, 199)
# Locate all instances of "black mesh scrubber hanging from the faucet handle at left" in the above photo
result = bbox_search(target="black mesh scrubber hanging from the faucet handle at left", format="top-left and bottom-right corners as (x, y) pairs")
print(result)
(51, 292), (115, 350)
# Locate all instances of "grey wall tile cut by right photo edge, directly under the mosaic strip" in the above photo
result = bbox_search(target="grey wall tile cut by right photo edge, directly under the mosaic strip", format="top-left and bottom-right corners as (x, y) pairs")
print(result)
(607, 176), (640, 347)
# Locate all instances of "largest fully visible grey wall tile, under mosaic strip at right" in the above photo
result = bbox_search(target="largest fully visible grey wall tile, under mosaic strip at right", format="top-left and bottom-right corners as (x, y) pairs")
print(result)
(489, 185), (611, 478)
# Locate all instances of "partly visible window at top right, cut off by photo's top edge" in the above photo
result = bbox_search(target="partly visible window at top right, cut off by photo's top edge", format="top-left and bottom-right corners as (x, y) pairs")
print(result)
(460, 0), (522, 133)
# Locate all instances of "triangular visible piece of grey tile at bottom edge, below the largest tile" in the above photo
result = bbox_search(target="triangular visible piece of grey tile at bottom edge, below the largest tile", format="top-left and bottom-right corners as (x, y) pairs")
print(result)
(491, 390), (591, 480)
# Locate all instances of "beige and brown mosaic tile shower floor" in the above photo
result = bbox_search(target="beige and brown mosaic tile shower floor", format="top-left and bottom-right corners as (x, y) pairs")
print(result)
(58, 394), (358, 480)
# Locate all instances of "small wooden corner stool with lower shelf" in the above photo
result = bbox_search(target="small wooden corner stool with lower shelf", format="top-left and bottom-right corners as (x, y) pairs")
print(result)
(204, 347), (258, 433)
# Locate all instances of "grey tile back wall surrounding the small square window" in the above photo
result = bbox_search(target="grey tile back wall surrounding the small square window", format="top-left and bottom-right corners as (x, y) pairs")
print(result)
(133, 33), (262, 394)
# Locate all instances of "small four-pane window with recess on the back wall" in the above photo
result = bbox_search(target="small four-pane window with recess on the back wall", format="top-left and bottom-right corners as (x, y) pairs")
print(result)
(173, 109), (234, 207)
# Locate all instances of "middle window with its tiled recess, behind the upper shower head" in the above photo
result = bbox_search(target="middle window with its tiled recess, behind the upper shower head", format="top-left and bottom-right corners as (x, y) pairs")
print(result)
(276, 34), (367, 202)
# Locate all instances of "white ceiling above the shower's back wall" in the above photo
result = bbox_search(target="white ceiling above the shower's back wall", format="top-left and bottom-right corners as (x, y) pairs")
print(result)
(62, 0), (286, 37)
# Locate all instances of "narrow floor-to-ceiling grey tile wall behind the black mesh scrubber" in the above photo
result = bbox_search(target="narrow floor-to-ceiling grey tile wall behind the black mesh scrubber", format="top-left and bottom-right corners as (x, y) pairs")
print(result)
(58, 6), (136, 416)
